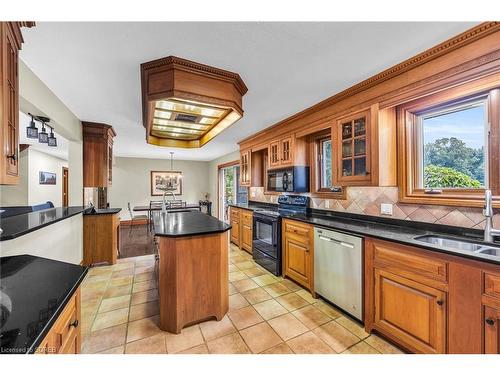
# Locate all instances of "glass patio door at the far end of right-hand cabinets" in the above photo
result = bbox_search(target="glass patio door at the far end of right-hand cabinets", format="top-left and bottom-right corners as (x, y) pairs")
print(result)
(217, 160), (248, 223)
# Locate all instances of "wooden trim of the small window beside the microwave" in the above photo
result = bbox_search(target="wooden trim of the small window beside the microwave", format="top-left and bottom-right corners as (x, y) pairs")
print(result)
(308, 129), (347, 200)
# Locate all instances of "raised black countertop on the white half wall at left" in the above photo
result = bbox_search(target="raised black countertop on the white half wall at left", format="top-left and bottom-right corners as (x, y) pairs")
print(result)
(0, 206), (86, 241)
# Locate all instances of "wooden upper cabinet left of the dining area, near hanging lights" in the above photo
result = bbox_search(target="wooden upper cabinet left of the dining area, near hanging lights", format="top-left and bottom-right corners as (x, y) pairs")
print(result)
(82, 121), (116, 187)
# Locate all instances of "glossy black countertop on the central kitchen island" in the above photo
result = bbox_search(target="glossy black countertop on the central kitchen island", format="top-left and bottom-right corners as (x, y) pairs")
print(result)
(153, 211), (231, 237)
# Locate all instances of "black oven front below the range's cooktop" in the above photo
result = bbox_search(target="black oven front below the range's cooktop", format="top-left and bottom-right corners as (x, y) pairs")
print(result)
(252, 212), (281, 276)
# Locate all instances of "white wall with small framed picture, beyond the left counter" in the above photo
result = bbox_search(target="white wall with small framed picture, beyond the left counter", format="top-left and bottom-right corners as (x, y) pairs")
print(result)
(28, 148), (68, 207)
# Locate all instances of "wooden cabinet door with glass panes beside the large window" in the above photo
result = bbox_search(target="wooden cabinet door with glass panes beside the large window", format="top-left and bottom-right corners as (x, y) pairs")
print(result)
(332, 110), (372, 186)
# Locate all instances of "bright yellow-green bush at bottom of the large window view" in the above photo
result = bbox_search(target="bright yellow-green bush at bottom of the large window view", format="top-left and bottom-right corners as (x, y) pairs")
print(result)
(424, 165), (481, 188)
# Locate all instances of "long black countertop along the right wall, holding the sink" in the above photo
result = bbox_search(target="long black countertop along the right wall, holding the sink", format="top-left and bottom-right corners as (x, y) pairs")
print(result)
(230, 202), (500, 264)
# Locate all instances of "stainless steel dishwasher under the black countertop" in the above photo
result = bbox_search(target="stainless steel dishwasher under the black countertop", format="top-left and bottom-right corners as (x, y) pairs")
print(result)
(314, 228), (363, 320)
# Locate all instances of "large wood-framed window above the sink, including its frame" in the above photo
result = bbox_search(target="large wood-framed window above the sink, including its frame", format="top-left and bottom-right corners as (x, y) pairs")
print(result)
(398, 88), (500, 206)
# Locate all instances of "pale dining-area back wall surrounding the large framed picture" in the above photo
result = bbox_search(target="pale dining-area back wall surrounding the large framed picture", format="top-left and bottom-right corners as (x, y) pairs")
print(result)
(108, 157), (213, 220)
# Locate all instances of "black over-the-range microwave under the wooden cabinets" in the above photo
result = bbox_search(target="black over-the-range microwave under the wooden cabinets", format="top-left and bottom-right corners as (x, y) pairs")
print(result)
(267, 167), (309, 193)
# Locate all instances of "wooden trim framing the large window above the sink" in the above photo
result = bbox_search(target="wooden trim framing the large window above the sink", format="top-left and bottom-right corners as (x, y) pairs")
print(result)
(397, 80), (500, 207)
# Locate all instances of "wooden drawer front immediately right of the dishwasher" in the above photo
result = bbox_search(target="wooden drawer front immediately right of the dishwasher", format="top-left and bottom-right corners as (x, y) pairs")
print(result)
(374, 241), (448, 283)
